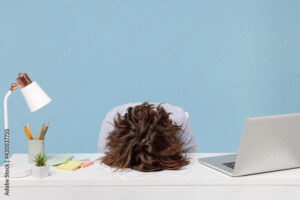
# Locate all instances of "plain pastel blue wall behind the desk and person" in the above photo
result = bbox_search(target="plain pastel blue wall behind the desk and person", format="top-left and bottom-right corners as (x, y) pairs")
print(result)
(0, 0), (300, 162)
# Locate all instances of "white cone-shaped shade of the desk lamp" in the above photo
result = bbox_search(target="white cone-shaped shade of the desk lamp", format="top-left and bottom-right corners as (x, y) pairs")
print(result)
(21, 81), (51, 112)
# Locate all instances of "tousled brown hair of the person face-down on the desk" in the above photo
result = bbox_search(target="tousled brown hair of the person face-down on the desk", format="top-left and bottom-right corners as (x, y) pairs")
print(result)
(101, 102), (189, 172)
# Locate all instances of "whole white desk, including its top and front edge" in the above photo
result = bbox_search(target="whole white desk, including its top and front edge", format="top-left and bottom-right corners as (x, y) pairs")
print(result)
(0, 154), (300, 200)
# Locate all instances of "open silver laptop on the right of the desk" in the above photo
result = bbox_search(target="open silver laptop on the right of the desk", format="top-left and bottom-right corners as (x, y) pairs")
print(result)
(199, 113), (300, 177)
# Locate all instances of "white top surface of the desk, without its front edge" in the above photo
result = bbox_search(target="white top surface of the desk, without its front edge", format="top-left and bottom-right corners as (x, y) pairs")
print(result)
(0, 153), (300, 187)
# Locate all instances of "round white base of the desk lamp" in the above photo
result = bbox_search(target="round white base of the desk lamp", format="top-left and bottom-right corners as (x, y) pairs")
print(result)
(0, 164), (32, 178)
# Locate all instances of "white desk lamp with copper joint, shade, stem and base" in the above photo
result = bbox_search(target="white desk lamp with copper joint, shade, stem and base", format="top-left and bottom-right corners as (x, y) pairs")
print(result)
(1, 73), (51, 177)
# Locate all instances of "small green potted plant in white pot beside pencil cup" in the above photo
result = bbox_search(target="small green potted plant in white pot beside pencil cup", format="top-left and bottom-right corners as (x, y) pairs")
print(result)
(32, 153), (49, 178)
